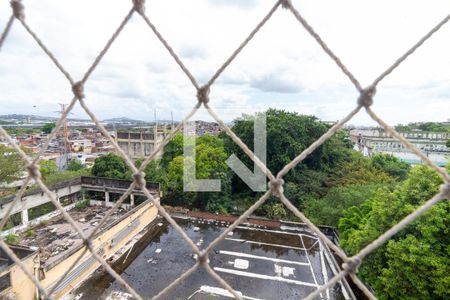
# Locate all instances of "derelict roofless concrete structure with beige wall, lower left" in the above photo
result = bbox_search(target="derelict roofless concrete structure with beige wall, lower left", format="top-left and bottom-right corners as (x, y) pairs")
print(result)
(0, 177), (159, 299)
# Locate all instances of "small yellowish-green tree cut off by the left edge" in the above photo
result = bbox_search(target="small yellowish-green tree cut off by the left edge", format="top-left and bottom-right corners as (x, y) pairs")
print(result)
(0, 145), (25, 183)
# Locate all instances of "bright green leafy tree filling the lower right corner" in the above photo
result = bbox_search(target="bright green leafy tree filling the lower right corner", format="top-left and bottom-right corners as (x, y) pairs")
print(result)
(339, 166), (450, 299)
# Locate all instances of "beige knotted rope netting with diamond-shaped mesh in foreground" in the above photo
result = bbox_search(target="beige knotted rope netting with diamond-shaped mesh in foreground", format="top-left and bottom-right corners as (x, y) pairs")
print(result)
(0, 0), (450, 299)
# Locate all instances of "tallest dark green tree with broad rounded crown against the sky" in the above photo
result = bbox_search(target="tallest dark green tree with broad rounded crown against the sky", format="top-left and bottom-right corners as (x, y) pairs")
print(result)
(221, 109), (352, 208)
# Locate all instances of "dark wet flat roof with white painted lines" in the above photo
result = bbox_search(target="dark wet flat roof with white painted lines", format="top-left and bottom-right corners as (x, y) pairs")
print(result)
(73, 218), (348, 300)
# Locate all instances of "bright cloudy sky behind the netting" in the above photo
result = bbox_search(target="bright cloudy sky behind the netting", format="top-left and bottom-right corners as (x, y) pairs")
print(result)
(0, 0), (450, 125)
